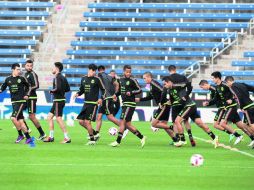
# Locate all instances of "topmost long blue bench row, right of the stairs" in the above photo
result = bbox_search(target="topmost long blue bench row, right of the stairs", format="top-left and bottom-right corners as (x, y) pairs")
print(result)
(88, 3), (254, 10)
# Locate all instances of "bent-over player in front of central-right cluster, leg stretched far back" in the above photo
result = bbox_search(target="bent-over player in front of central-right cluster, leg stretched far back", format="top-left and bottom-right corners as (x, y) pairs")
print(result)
(163, 76), (219, 148)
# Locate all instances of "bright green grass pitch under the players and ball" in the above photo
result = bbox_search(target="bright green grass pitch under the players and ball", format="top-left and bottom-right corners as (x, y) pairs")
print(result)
(0, 120), (254, 190)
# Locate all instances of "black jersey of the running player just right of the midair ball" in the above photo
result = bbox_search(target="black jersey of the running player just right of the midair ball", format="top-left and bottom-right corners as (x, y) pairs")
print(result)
(119, 77), (142, 107)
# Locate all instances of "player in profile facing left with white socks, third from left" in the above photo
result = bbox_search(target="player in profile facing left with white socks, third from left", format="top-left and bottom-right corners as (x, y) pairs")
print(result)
(43, 62), (71, 144)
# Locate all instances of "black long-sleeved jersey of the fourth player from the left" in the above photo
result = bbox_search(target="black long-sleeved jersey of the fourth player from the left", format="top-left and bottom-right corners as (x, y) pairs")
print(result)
(77, 75), (106, 104)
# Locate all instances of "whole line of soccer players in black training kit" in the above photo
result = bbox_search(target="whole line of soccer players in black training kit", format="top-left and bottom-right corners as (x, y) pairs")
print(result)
(0, 60), (254, 148)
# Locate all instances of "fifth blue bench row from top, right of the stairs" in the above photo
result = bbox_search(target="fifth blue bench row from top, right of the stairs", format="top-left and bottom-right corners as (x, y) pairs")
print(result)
(71, 41), (224, 48)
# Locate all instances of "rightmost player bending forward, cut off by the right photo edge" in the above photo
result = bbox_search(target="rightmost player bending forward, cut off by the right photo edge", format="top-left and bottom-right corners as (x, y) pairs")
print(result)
(225, 76), (254, 148)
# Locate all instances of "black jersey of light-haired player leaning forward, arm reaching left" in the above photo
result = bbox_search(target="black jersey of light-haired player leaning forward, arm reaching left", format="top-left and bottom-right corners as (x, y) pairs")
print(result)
(140, 79), (163, 105)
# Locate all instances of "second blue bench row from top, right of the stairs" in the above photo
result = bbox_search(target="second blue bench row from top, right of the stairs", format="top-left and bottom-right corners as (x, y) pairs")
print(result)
(84, 12), (254, 20)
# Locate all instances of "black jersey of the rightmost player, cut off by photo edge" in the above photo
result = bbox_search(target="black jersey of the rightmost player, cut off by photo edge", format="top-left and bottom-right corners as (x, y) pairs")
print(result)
(230, 82), (254, 109)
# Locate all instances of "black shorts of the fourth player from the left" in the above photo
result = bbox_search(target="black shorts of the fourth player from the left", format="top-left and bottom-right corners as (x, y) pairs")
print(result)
(77, 103), (98, 121)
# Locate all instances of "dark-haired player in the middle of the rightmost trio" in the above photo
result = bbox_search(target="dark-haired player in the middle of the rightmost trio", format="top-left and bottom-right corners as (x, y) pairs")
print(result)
(211, 71), (246, 145)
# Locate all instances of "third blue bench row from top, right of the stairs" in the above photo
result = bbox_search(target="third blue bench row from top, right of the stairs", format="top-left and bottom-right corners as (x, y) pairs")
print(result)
(80, 21), (249, 29)
